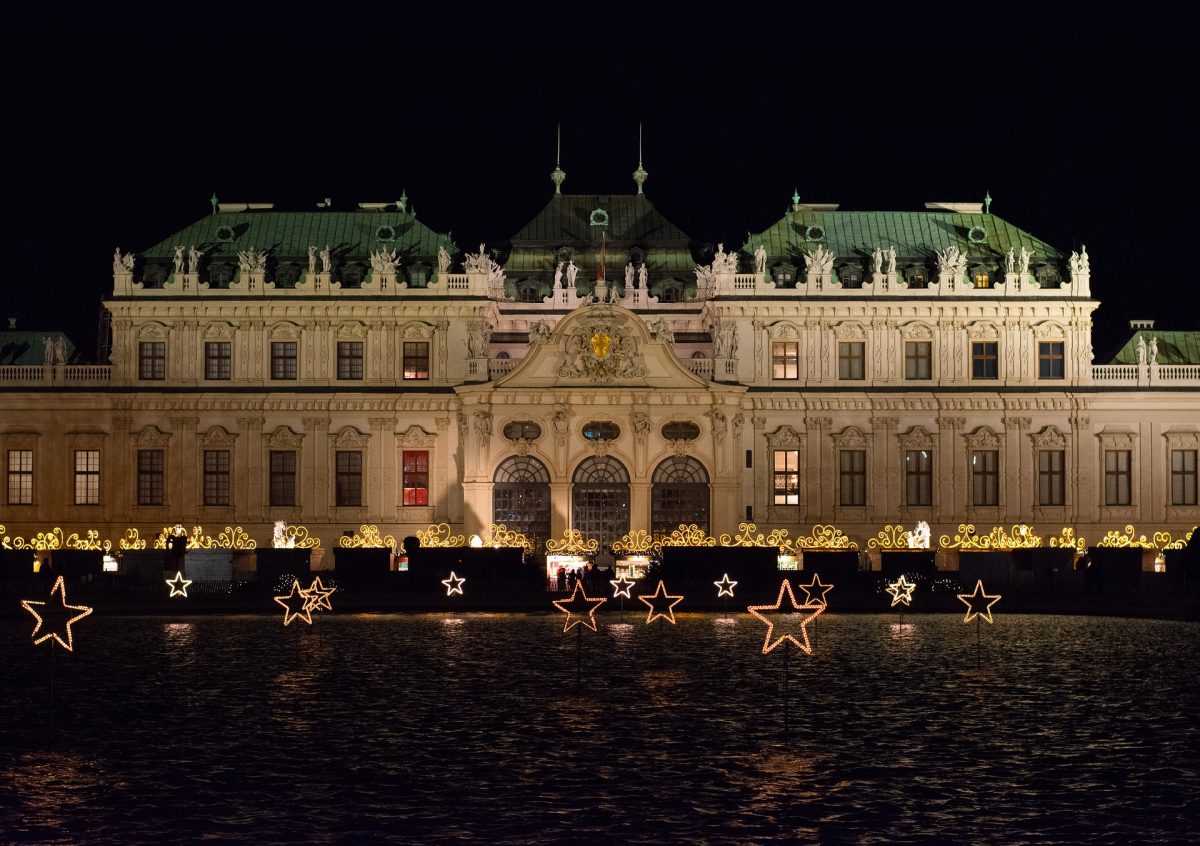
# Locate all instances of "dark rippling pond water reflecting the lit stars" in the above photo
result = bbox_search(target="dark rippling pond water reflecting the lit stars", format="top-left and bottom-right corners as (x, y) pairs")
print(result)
(0, 611), (1200, 844)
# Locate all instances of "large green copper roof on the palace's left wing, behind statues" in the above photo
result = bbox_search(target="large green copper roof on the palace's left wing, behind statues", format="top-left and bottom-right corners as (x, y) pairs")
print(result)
(142, 211), (457, 260)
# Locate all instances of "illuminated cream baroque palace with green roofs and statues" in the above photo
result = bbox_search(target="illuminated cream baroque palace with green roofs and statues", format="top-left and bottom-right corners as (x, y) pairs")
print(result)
(0, 168), (1200, 556)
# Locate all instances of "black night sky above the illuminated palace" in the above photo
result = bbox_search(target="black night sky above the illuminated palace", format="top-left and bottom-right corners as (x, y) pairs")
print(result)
(7, 2), (1200, 360)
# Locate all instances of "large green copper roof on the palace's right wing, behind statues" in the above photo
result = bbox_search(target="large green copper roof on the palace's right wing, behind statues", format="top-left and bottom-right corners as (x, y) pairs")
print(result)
(742, 209), (1064, 268)
